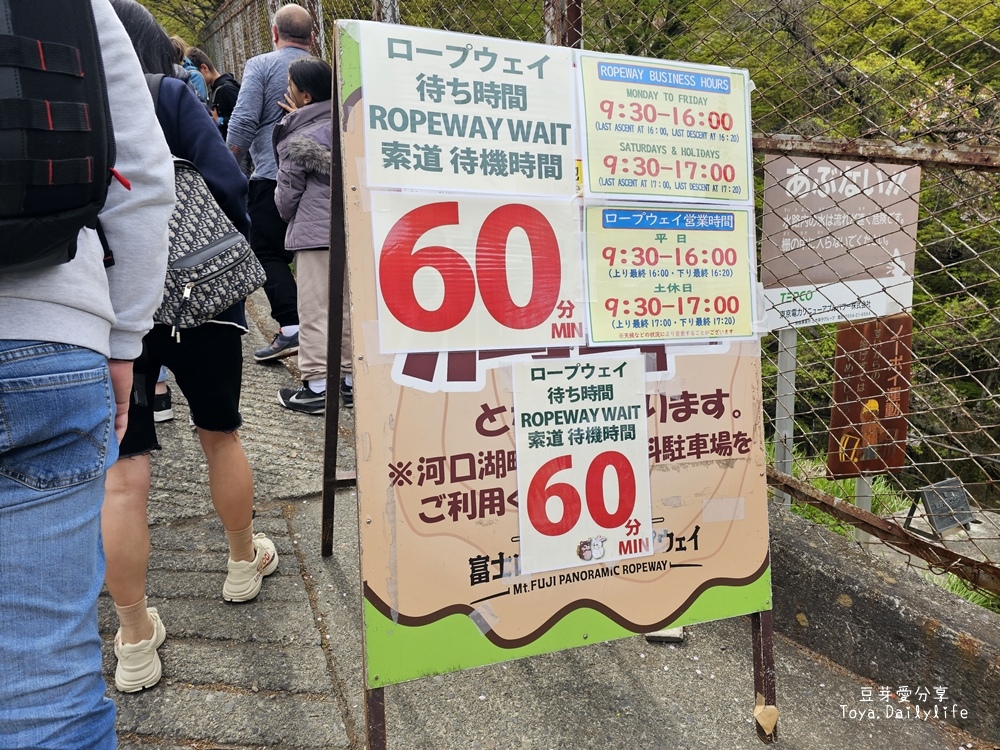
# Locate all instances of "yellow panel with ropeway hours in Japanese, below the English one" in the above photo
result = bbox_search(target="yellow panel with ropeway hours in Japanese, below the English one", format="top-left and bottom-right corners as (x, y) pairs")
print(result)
(584, 206), (755, 344)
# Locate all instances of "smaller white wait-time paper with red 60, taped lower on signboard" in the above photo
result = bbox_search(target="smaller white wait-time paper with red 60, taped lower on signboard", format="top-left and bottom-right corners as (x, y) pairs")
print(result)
(513, 350), (652, 573)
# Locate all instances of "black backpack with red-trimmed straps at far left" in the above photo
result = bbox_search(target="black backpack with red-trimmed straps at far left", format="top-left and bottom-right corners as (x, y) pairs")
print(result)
(0, 0), (115, 272)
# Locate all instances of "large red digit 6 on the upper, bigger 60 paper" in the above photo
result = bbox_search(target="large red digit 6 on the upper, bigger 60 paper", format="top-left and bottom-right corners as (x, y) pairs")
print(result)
(379, 206), (476, 333)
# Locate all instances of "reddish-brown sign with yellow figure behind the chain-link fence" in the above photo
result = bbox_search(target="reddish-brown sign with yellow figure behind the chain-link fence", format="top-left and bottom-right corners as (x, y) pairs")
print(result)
(826, 313), (913, 479)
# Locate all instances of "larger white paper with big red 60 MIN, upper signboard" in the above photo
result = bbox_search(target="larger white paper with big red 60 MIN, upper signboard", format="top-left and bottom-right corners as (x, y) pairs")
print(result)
(375, 194), (583, 351)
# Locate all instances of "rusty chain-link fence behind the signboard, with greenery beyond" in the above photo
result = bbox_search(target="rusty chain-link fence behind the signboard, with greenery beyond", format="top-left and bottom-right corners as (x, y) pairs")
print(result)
(202, 0), (1000, 600)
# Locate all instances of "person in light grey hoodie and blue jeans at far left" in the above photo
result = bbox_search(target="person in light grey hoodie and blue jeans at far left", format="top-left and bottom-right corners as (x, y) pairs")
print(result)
(0, 0), (174, 750)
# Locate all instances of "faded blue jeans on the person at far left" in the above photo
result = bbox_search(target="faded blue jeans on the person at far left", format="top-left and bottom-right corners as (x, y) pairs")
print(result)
(0, 340), (118, 750)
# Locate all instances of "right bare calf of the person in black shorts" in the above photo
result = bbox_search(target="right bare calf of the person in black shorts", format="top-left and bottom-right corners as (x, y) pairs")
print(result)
(198, 427), (253, 560)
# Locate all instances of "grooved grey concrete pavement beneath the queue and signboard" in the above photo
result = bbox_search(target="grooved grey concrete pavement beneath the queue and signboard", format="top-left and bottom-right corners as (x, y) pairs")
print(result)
(100, 293), (993, 750)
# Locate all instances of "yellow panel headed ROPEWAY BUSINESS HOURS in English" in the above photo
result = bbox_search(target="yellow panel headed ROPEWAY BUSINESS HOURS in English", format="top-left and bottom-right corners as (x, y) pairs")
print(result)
(579, 54), (753, 203)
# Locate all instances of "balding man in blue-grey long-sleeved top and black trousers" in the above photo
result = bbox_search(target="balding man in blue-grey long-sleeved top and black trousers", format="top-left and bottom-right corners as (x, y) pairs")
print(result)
(226, 3), (313, 362)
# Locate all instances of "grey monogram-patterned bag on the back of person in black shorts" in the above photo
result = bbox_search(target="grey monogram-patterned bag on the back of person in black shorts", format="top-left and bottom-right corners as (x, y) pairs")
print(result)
(153, 157), (264, 335)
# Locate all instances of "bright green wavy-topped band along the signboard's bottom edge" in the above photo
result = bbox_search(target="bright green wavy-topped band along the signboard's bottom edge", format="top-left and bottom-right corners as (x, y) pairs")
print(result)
(364, 568), (771, 688)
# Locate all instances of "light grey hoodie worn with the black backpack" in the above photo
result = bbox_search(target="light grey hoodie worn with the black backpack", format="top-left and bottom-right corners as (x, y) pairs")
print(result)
(0, 0), (174, 359)
